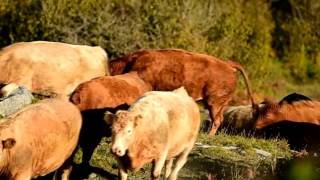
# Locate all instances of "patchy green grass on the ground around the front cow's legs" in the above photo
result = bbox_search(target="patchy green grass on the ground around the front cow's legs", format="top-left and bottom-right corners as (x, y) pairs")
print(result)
(74, 132), (291, 180)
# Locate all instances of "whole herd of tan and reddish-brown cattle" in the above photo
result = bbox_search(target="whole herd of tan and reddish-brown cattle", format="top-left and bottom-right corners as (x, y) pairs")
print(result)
(0, 41), (320, 180)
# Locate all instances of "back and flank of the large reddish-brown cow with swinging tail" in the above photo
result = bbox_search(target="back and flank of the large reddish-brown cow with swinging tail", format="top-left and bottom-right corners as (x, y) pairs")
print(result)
(110, 49), (236, 100)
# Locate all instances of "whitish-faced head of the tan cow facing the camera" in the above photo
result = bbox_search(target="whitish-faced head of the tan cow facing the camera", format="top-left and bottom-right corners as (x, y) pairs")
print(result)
(105, 110), (142, 156)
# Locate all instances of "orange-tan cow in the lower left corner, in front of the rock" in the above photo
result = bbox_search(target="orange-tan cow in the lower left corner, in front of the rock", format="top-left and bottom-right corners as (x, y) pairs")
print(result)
(0, 99), (82, 180)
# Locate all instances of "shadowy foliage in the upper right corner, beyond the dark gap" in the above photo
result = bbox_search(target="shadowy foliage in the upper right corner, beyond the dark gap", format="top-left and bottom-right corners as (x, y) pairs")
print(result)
(271, 0), (320, 80)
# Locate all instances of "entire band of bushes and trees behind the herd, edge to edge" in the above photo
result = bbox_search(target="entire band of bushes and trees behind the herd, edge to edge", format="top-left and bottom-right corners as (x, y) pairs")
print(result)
(0, 0), (320, 98)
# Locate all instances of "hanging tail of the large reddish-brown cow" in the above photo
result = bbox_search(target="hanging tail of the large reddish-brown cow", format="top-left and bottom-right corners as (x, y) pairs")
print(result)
(228, 61), (259, 117)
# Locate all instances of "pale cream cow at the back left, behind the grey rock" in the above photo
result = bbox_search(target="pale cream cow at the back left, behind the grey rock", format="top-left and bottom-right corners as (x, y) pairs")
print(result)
(0, 41), (109, 96)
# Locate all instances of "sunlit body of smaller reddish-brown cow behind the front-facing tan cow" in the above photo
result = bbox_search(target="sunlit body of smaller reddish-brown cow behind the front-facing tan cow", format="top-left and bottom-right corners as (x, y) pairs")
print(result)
(70, 72), (151, 111)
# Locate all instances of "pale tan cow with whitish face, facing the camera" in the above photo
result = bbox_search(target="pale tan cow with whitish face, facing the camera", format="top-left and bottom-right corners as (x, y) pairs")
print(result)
(106, 88), (200, 179)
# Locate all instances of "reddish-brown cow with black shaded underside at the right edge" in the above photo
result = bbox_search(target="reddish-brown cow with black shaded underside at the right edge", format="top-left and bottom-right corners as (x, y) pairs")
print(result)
(255, 93), (320, 153)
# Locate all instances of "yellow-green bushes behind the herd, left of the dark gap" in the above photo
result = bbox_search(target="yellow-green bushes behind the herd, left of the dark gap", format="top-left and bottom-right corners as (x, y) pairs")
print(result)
(0, 0), (273, 79)
